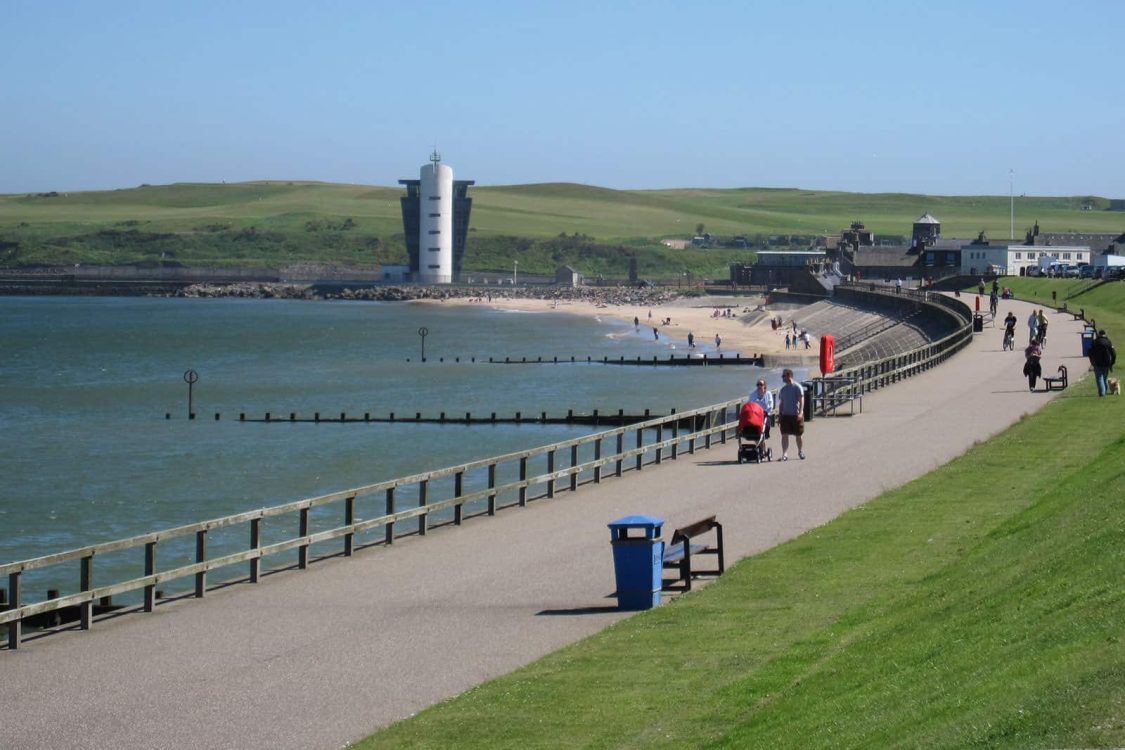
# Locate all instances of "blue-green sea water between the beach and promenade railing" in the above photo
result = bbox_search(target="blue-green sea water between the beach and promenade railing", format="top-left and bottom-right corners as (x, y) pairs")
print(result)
(0, 297), (758, 591)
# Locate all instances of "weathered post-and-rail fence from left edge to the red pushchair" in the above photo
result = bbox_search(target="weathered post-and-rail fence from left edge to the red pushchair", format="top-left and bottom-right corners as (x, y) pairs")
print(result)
(0, 400), (740, 649)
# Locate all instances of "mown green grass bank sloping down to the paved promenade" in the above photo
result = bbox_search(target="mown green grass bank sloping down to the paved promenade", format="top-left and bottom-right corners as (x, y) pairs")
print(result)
(361, 284), (1125, 748)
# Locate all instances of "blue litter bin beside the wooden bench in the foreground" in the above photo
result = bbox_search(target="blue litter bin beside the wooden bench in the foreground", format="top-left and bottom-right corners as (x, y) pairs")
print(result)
(609, 516), (664, 609)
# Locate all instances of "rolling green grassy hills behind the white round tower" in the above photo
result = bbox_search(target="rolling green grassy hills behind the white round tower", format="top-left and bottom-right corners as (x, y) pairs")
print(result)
(0, 182), (1125, 277)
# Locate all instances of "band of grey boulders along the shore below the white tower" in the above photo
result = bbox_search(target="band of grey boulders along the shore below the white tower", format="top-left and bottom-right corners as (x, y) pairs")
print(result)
(169, 282), (680, 306)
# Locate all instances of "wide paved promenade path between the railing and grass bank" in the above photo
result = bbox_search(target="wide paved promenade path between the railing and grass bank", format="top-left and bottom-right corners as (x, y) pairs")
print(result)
(0, 301), (1092, 750)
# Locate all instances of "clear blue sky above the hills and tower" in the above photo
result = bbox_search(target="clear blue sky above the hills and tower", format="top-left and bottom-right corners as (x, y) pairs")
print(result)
(0, 0), (1125, 198)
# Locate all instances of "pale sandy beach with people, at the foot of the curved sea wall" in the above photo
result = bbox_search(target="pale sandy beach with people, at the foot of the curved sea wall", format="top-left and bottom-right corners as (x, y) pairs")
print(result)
(434, 297), (816, 359)
